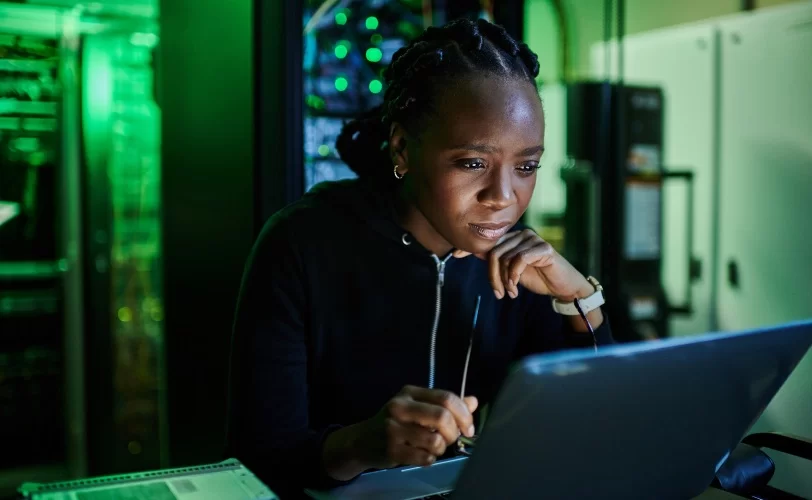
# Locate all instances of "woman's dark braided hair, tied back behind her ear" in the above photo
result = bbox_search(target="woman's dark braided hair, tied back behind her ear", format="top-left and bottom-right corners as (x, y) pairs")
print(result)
(336, 19), (539, 182)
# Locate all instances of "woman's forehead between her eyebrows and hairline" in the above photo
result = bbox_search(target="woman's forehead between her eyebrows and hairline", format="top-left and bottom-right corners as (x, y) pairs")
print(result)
(423, 77), (544, 149)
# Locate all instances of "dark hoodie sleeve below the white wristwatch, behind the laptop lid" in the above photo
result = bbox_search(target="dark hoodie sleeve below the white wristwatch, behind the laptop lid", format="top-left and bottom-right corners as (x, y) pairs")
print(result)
(514, 294), (615, 360)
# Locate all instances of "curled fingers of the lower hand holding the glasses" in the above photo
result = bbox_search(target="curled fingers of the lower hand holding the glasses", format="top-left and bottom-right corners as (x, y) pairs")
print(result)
(392, 386), (474, 438)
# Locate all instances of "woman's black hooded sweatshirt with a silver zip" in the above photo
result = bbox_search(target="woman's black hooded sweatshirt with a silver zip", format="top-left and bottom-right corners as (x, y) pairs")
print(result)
(228, 180), (612, 498)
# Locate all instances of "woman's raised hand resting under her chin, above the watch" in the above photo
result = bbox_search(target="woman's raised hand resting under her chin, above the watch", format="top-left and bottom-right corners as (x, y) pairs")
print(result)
(454, 229), (595, 302)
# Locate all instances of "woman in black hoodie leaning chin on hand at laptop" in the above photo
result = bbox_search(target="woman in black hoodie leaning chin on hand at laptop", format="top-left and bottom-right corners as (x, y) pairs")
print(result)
(229, 16), (611, 491)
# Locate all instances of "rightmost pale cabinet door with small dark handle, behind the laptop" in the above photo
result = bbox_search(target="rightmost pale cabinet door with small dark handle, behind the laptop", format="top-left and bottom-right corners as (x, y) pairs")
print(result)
(717, 2), (812, 498)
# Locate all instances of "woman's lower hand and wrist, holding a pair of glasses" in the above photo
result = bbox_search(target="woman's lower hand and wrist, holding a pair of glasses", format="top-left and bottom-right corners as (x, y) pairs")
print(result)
(324, 386), (478, 480)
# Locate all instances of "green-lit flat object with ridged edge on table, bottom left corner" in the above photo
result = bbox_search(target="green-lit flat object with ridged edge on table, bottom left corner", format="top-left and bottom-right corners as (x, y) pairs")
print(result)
(19, 459), (279, 500)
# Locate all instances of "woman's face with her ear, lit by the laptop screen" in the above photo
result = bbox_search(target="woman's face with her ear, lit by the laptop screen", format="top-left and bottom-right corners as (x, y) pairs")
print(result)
(392, 77), (544, 254)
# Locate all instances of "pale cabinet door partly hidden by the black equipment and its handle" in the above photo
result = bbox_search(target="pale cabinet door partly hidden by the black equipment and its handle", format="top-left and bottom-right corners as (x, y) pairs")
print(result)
(591, 23), (716, 335)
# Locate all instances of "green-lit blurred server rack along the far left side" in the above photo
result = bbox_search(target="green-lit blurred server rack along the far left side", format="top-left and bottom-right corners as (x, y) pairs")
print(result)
(0, 4), (166, 494)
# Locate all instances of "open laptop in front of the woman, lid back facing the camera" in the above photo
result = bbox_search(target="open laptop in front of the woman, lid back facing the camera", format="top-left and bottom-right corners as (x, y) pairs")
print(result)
(306, 321), (812, 500)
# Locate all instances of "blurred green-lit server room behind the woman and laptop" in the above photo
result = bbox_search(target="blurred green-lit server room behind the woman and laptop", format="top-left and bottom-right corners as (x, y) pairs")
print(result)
(0, 0), (812, 497)
